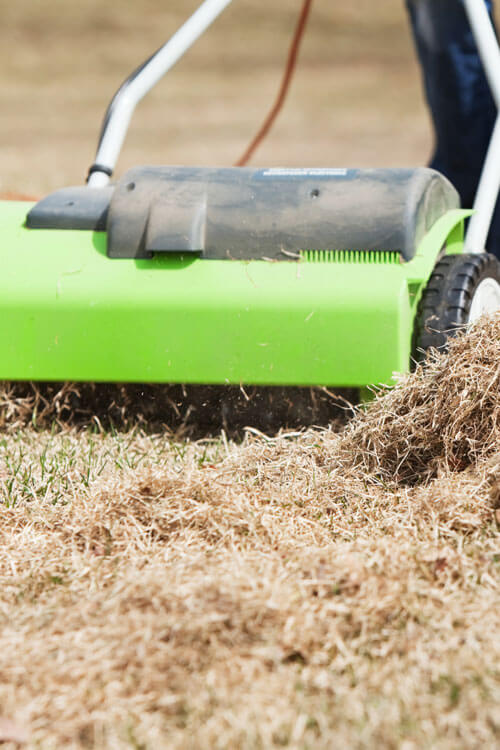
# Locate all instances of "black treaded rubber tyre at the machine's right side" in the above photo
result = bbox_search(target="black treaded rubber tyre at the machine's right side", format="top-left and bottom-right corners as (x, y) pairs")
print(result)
(413, 253), (500, 362)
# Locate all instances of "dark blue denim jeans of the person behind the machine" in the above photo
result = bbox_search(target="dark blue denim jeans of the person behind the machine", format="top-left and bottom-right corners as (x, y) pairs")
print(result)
(406, 0), (500, 258)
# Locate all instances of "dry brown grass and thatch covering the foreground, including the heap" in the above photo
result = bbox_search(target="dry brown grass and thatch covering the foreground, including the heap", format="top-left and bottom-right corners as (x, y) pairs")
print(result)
(0, 321), (500, 750)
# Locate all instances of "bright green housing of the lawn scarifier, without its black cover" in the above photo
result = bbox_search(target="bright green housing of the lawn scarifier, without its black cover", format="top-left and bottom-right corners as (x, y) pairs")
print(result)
(0, 195), (464, 386)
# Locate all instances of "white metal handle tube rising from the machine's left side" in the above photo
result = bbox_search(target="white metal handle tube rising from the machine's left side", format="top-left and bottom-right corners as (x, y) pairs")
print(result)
(87, 0), (232, 188)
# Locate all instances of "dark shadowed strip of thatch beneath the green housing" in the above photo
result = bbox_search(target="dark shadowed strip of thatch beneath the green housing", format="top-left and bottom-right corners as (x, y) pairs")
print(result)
(0, 382), (357, 439)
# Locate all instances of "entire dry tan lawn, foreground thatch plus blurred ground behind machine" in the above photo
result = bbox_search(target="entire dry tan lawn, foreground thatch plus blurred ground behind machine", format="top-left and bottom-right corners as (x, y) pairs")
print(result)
(0, 0), (500, 750)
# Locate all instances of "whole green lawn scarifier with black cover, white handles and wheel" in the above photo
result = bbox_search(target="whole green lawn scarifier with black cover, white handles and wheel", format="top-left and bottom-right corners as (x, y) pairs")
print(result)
(0, 0), (500, 394)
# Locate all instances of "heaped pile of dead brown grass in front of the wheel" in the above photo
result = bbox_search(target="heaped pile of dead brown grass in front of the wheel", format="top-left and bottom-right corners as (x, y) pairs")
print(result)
(340, 319), (500, 484)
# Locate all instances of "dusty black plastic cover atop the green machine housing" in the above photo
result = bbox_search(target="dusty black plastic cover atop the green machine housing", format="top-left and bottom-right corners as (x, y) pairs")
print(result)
(107, 166), (459, 260)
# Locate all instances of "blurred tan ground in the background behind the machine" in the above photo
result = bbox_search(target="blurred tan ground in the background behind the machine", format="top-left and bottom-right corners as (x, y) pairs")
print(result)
(0, 0), (432, 195)
